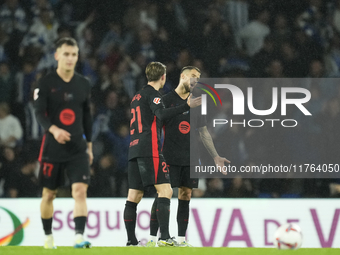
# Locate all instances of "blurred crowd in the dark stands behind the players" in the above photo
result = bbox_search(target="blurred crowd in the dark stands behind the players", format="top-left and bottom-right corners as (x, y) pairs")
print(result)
(0, 0), (340, 198)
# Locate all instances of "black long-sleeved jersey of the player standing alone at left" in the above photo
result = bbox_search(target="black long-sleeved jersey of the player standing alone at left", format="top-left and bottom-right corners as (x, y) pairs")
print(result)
(34, 71), (92, 162)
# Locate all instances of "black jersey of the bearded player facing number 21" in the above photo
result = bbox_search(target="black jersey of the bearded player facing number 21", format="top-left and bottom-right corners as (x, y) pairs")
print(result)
(163, 91), (207, 166)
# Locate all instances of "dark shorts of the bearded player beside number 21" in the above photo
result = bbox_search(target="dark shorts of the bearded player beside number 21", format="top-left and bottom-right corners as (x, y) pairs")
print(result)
(168, 165), (198, 189)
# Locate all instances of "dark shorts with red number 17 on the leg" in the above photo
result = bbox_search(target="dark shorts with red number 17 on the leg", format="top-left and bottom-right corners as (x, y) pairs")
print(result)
(39, 157), (90, 190)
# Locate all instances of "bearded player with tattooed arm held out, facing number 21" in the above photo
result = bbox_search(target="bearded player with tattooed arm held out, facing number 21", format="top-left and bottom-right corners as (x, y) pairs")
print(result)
(147, 66), (230, 247)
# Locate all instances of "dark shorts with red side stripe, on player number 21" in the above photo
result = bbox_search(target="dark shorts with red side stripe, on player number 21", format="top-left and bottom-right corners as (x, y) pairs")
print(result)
(128, 155), (170, 190)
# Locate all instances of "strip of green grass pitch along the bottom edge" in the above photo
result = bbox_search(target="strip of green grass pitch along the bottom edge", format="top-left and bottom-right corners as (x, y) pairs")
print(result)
(0, 246), (340, 255)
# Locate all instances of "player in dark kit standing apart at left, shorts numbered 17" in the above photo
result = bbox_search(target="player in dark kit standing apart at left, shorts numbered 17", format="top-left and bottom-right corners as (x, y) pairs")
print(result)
(34, 38), (93, 249)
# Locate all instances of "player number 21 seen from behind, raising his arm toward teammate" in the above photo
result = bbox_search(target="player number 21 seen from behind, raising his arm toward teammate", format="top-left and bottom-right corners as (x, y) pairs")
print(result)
(124, 62), (201, 246)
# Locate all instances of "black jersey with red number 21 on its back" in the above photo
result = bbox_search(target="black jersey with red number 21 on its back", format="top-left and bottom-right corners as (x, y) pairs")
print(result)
(129, 85), (190, 160)
